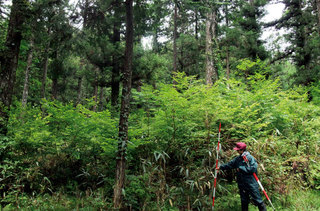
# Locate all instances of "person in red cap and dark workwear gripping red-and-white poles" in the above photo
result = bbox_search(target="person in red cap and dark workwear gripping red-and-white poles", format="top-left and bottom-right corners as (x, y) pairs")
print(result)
(217, 142), (267, 211)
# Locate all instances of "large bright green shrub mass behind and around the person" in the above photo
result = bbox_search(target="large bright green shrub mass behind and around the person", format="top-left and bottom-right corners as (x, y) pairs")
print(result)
(127, 73), (320, 208)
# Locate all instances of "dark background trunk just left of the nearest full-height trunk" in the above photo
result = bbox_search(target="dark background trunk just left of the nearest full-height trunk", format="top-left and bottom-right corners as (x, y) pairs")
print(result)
(111, 0), (121, 110)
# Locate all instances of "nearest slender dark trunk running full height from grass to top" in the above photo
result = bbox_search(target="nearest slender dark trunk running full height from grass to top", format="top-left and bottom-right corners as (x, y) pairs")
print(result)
(113, 0), (133, 209)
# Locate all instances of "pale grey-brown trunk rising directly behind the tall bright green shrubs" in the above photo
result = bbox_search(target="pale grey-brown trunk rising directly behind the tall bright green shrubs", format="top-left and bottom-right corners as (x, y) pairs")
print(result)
(206, 9), (218, 85)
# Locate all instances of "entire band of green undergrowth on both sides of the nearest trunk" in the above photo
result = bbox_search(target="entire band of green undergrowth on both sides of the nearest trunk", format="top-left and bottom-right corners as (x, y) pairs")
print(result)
(0, 74), (320, 210)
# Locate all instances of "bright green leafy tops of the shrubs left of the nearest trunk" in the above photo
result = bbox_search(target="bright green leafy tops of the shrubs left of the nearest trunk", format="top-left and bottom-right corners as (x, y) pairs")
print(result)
(9, 101), (116, 157)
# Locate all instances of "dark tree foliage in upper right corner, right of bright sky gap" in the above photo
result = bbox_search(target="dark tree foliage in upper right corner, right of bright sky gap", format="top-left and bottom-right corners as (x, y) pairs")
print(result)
(274, 0), (320, 85)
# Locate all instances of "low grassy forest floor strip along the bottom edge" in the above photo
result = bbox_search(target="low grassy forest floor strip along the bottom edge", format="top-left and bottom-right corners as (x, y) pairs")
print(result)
(1, 190), (320, 211)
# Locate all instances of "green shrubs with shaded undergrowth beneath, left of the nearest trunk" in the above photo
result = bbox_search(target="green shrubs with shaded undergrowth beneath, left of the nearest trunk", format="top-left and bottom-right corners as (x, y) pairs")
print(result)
(0, 101), (117, 206)
